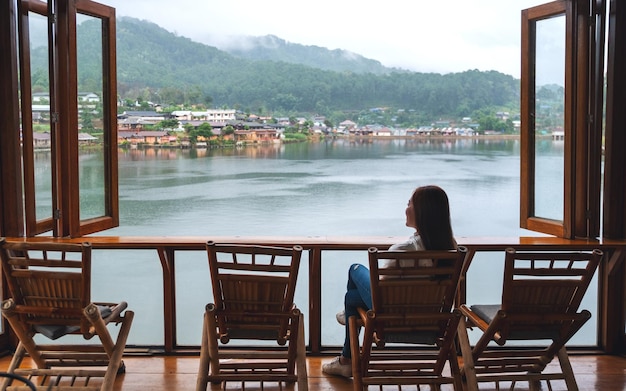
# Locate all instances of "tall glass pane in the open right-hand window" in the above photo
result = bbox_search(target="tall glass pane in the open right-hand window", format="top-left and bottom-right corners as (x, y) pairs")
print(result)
(535, 15), (565, 220)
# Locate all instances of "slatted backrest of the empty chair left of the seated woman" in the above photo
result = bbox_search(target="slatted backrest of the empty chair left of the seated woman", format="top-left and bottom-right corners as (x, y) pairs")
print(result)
(206, 242), (302, 344)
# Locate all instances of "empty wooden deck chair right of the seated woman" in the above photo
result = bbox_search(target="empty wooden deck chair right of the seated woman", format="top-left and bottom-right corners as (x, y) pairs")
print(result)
(459, 248), (602, 390)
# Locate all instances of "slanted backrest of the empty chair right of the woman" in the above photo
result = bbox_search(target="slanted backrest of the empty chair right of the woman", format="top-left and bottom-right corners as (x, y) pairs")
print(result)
(499, 248), (602, 339)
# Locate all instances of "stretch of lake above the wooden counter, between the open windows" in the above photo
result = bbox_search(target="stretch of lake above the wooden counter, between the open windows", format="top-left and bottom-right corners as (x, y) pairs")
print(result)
(112, 139), (522, 240)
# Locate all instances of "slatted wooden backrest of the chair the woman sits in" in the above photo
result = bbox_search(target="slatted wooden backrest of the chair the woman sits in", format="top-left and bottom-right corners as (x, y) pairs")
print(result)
(368, 247), (467, 343)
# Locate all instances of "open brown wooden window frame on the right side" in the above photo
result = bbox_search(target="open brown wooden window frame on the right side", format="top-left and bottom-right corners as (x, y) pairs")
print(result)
(520, 0), (604, 238)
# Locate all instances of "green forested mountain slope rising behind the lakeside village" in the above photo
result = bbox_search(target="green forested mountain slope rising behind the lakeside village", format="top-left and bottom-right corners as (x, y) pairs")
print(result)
(34, 17), (519, 120)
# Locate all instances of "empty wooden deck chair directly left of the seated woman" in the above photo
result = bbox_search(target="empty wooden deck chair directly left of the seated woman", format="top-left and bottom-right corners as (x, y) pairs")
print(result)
(196, 242), (308, 391)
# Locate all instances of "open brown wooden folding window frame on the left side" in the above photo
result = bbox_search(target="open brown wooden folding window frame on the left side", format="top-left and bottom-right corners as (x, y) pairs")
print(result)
(18, 0), (119, 237)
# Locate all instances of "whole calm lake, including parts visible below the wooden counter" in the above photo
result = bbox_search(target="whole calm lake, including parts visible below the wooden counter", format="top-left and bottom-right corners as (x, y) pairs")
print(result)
(62, 138), (596, 345)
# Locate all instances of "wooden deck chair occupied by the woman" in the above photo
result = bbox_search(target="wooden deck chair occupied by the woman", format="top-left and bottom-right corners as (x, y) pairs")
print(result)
(348, 247), (467, 390)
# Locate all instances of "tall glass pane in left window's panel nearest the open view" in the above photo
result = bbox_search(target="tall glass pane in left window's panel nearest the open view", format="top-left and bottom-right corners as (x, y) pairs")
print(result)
(76, 14), (106, 220)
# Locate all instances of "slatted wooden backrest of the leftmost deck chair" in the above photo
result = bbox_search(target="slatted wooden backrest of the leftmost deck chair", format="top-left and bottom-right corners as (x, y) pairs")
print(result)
(0, 238), (91, 335)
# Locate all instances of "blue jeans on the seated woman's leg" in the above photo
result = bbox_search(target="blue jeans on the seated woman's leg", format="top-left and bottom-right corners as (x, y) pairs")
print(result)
(341, 263), (372, 358)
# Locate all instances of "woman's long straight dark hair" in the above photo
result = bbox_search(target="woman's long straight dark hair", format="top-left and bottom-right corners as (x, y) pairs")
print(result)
(411, 186), (456, 250)
